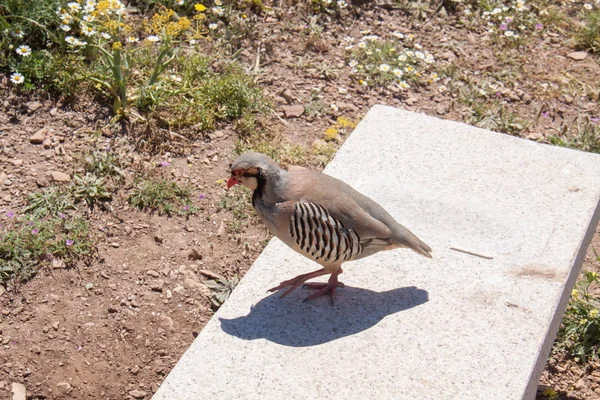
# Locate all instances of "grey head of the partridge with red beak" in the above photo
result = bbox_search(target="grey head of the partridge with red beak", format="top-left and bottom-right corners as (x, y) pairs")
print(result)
(227, 152), (279, 190)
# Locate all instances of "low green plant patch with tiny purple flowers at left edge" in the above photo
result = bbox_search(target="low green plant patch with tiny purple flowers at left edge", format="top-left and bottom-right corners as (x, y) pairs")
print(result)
(0, 215), (95, 283)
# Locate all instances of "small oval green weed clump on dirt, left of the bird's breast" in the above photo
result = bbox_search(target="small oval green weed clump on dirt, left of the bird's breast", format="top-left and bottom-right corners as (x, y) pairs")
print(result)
(129, 179), (197, 215)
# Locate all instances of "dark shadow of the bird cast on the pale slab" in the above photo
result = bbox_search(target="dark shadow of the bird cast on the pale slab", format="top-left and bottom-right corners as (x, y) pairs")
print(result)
(219, 286), (429, 347)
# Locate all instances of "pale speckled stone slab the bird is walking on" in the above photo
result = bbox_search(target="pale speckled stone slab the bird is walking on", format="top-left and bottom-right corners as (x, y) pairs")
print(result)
(154, 106), (600, 400)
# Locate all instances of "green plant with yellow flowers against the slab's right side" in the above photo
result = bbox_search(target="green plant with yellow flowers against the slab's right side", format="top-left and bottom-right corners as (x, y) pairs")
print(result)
(556, 272), (600, 363)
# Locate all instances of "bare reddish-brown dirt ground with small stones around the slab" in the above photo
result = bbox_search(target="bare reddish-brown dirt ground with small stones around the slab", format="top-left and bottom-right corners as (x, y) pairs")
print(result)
(0, 4), (600, 400)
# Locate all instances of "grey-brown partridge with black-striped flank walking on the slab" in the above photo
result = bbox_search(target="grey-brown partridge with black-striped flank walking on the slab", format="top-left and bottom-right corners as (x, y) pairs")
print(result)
(227, 153), (431, 302)
